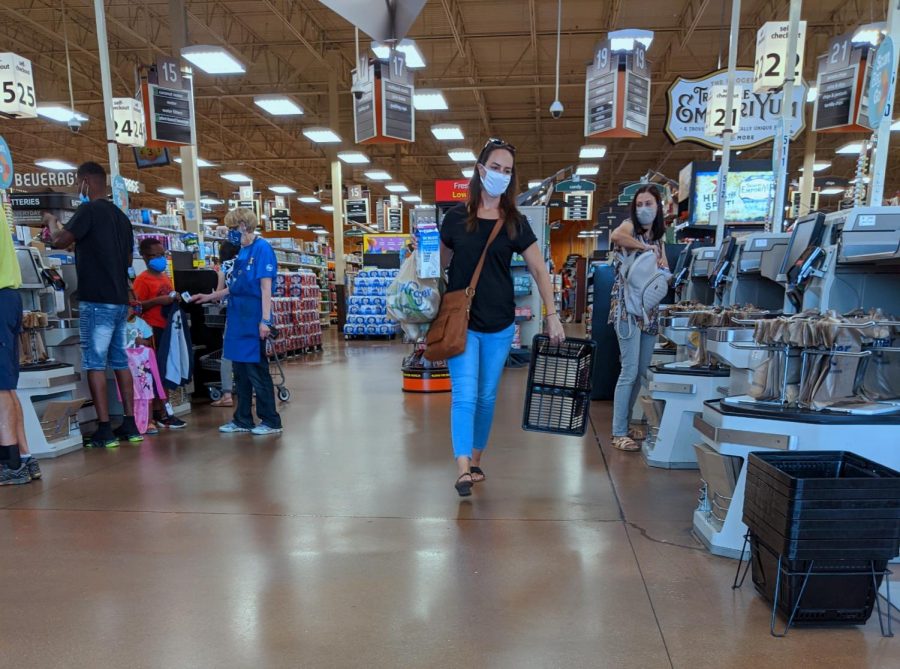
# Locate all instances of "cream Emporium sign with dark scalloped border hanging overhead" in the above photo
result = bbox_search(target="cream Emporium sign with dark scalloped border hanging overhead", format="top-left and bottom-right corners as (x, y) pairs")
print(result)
(666, 67), (807, 149)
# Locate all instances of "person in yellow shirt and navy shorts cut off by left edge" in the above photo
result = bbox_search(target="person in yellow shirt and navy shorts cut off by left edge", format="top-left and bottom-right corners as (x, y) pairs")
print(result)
(0, 203), (41, 486)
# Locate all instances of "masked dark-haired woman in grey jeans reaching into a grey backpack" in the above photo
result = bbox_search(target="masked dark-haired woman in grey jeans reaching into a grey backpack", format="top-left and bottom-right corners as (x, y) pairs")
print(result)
(609, 184), (669, 451)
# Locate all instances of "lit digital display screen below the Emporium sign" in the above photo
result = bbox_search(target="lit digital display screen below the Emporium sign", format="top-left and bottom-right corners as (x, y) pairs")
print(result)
(691, 172), (775, 225)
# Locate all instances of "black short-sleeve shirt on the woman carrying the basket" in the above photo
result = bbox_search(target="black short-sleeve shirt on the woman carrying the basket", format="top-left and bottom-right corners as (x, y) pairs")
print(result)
(441, 204), (537, 333)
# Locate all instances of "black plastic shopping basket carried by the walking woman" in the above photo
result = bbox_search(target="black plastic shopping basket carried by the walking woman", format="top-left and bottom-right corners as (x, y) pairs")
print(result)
(522, 335), (594, 437)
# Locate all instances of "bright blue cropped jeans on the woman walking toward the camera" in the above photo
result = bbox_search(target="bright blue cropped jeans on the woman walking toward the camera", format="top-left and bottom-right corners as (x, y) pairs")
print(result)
(447, 324), (516, 458)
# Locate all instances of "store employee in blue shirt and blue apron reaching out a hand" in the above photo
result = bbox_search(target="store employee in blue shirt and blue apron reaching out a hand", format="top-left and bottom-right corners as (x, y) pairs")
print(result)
(194, 209), (281, 435)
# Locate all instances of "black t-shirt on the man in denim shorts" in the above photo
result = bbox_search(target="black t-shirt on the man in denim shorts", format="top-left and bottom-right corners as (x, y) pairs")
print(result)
(66, 199), (134, 304)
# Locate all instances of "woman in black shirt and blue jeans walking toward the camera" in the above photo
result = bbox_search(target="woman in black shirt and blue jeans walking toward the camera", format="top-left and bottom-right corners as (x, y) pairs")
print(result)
(441, 139), (565, 497)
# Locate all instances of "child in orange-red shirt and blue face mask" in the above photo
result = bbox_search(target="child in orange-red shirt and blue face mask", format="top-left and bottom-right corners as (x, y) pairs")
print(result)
(133, 238), (187, 434)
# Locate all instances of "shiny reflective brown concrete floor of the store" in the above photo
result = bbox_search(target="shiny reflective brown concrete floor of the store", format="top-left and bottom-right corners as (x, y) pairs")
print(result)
(0, 339), (900, 669)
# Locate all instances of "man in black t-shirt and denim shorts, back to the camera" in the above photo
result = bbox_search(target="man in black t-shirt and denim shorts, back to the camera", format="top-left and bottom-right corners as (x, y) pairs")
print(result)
(53, 162), (143, 448)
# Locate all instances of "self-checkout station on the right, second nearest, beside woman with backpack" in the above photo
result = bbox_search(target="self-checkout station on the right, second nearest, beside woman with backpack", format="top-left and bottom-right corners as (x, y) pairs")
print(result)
(642, 233), (789, 469)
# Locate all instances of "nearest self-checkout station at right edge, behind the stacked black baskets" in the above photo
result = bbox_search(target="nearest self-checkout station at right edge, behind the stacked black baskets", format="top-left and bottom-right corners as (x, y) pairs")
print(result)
(693, 207), (900, 557)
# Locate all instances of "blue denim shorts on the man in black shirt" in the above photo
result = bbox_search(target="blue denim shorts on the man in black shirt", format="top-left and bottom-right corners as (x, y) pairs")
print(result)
(78, 302), (128, 371)
